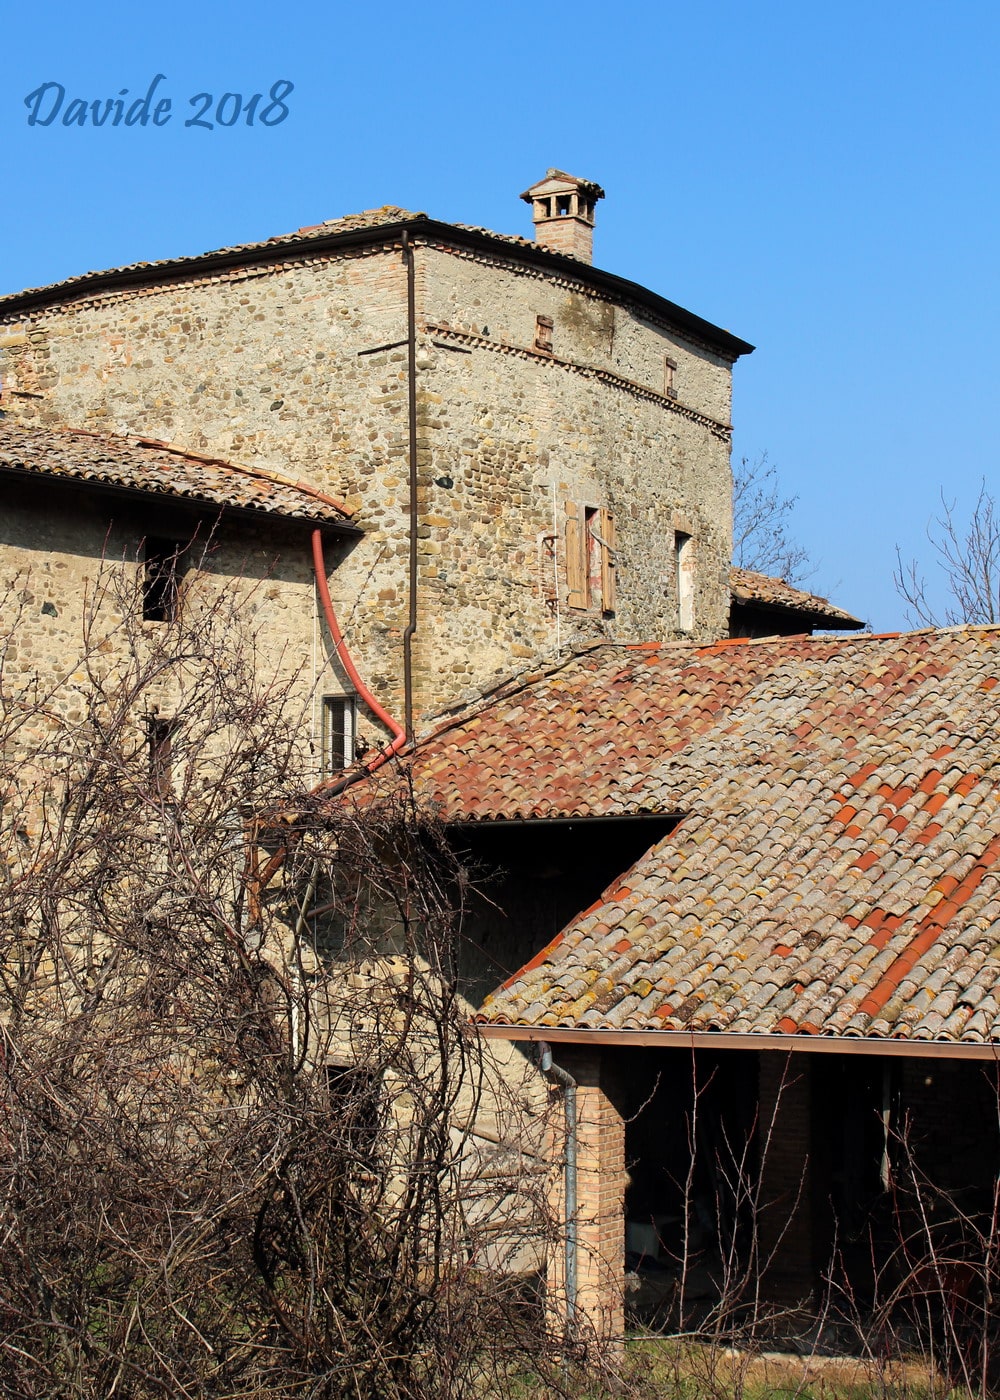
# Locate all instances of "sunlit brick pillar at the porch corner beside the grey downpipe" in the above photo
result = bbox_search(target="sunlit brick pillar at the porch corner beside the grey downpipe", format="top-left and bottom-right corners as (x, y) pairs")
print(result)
(548, 1046), (625, 1347)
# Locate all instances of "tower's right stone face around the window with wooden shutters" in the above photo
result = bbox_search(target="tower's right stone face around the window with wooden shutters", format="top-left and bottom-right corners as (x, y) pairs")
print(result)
(419, 249), (731, 711)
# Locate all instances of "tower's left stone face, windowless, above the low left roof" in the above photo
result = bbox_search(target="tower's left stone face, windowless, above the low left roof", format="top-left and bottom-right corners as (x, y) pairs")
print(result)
(0, 249), (417, 741)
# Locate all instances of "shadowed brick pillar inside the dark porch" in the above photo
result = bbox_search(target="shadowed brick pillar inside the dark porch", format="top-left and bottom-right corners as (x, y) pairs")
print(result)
(756, 1050), (814, 1306)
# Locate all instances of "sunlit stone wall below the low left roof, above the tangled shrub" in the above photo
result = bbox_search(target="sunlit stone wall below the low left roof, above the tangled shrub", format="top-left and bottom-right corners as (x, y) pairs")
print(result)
(0, 480), (345, 780)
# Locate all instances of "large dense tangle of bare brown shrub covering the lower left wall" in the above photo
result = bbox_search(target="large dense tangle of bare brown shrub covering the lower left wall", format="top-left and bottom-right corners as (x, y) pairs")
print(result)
(0, 551), (556, 1400)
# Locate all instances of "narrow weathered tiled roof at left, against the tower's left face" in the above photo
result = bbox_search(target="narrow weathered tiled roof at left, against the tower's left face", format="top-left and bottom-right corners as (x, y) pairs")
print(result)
(0, 417), (349, 525)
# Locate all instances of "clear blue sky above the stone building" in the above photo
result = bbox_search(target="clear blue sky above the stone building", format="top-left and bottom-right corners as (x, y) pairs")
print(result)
(0, 0), (1000, 630)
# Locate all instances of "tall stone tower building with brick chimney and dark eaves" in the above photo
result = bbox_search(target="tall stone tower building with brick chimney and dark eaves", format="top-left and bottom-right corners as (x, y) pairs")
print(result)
(0, 171), (752, 738)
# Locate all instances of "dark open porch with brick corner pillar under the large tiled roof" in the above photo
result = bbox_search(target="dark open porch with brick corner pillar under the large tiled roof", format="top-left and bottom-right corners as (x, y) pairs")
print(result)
(483, 1028), (1000, 1350)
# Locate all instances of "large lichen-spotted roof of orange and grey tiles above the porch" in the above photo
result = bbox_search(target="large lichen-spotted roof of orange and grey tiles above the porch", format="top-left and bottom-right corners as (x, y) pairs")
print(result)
(400, 629), (1000, 1044)
